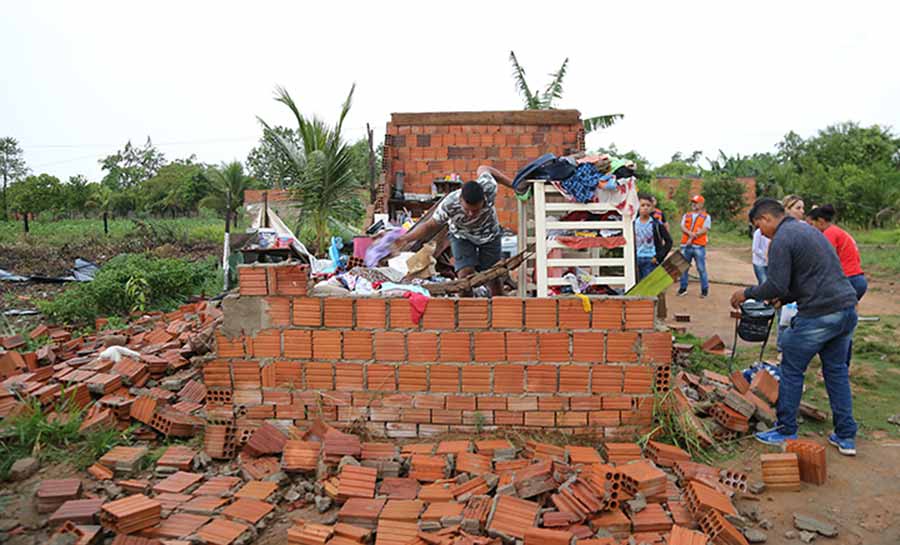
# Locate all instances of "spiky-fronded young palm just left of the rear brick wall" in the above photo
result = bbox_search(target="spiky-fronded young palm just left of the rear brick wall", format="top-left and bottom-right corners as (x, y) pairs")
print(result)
(258, 84), (363, 252)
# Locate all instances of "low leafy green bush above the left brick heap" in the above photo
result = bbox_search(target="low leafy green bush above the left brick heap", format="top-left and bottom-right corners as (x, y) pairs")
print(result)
(38, 254), (216, 324)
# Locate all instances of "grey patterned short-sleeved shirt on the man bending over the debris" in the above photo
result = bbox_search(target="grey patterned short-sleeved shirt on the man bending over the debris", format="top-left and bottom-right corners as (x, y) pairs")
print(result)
(433, 172), (503, 244)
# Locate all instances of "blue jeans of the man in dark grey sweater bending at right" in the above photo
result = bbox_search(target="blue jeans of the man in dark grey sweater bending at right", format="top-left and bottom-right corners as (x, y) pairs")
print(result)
(777, 308), (857, 439)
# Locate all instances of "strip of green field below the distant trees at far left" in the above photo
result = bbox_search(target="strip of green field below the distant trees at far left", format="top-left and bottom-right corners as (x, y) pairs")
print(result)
(0, 216), (225, 247)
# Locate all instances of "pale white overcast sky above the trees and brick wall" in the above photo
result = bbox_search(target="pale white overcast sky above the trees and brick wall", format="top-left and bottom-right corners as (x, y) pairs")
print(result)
(0, 0), (900, 180)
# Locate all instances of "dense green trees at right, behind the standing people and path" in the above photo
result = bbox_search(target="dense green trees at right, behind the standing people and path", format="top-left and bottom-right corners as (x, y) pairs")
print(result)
(598, 122), (900, 228)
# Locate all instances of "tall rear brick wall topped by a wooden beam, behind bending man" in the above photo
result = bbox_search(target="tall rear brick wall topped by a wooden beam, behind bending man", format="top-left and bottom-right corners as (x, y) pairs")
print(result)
(381, 110), (584, 231)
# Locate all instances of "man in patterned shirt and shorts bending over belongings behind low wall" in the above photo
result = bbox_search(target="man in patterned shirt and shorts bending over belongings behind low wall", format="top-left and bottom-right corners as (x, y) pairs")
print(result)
(394, 165), (512, 295)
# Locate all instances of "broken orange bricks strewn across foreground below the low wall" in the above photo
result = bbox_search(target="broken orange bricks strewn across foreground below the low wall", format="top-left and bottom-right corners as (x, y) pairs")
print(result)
(17, 412), (788, 545)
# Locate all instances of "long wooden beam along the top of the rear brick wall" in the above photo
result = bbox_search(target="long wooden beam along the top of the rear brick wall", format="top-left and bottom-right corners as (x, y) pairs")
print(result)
(391, 110), (581, 127)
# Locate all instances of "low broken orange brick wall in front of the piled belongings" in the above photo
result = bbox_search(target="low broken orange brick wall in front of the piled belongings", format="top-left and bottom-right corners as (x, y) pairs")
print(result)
(213, 265), (672, 438)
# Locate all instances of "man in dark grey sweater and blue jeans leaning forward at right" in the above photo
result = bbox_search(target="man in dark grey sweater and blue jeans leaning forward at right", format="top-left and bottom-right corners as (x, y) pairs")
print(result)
(731, 198), (857, 456)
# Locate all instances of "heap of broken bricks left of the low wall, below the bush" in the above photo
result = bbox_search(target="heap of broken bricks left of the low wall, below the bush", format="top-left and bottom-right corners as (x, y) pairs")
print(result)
(0, 301), (222, 432)
